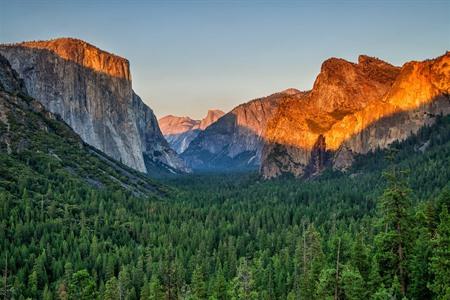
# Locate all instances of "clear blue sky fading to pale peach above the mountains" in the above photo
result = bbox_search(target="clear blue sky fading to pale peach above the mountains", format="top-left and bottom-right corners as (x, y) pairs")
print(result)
(0, 0), (450, 119)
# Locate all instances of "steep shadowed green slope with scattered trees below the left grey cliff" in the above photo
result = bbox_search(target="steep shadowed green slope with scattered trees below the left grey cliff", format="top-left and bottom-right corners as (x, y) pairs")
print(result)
(0, 55), (166, 196)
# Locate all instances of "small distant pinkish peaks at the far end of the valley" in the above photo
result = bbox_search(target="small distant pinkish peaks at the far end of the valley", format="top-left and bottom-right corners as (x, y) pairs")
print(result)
(158, 109), (225, 153)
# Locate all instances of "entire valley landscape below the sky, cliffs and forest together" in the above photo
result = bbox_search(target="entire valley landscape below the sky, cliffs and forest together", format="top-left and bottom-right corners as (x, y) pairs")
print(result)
(0, 34), (450, 300)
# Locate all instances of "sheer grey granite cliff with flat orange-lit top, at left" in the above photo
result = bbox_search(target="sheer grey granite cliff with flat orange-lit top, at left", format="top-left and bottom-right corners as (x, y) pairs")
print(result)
(0, 38), (188, 172)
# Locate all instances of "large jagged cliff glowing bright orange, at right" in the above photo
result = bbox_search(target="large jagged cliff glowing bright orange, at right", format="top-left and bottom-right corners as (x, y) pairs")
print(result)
(261, 53), (450, 178)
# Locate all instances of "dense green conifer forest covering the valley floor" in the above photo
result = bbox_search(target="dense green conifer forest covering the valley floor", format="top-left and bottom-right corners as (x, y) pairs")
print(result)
(0, 113), (450, 300)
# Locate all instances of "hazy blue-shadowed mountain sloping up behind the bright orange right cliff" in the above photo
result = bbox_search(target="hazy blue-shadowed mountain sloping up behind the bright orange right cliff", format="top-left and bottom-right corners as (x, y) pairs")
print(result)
(182, 89), (302, 170)
